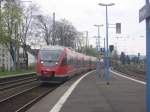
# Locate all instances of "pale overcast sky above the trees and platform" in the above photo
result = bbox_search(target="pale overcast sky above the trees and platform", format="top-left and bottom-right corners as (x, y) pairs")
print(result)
(32, 0), (145, 54)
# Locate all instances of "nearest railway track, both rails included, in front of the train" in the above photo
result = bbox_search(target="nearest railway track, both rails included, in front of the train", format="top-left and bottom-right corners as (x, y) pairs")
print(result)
(0, 85), (58, 112)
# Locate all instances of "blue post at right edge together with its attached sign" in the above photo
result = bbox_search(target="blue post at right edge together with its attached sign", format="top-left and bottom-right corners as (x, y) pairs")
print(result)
(139, 0), (150, 112)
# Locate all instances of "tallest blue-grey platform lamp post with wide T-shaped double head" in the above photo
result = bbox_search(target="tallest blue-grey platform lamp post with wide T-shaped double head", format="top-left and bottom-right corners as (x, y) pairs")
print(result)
(98, 3), (115, 85)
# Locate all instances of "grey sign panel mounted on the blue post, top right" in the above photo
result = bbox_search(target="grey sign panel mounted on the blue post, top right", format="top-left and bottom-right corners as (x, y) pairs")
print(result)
(139, 3), (150, 22)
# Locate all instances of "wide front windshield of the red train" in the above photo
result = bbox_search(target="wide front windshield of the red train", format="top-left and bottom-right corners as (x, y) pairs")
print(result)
(40, 50), (62, 61)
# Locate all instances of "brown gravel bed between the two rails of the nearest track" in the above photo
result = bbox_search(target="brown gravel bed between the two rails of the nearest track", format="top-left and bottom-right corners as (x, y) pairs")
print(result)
(0, 86), (57, 112)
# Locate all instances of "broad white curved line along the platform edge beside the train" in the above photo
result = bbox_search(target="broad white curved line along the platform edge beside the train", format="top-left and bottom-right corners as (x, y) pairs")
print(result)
(49, 70), (95, 112)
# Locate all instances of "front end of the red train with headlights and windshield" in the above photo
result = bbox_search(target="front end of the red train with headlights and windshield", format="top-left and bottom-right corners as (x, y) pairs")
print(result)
(36, 47), (64, 83)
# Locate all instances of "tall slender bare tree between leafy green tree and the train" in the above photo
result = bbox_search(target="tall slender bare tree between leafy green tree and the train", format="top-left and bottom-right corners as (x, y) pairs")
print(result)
(19, 4), (38, 68)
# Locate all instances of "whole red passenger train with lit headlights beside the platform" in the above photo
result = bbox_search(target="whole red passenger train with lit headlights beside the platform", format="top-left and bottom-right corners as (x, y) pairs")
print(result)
(36, 46), (96, 83)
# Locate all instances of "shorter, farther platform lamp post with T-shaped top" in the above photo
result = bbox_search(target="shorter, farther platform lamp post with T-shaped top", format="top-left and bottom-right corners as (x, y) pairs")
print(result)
(94, 24), (104, 78)
